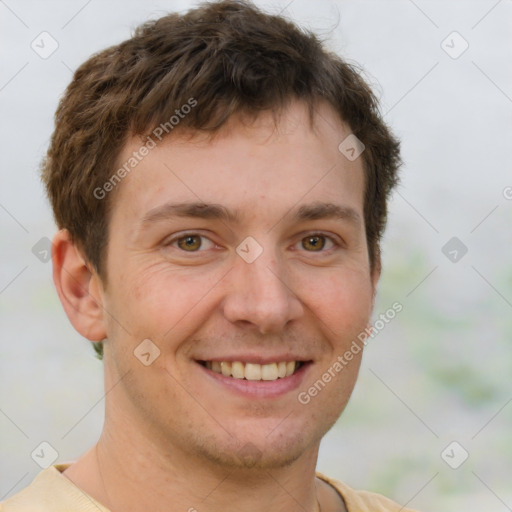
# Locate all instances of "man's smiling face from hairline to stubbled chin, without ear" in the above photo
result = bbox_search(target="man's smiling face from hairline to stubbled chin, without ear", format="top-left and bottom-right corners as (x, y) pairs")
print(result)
(96, 103), (376, 468)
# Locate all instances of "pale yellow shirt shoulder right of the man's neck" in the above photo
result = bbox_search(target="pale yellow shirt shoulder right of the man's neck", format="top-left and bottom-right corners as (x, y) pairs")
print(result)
(316, 471), (415, 512)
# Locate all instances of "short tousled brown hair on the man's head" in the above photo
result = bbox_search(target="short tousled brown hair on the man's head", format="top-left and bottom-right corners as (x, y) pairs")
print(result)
(42, 0), (400, 356)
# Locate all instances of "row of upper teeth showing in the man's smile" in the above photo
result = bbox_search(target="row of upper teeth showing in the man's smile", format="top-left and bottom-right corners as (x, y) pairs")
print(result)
(206, 361), (299, 380)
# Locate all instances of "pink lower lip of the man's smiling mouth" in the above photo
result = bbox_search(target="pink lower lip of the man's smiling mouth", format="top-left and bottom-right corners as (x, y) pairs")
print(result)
(196, 362), (312, 399)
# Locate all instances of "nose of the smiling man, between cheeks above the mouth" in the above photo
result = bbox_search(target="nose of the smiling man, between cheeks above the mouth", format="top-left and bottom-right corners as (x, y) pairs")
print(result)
(223, 245), (304, 334)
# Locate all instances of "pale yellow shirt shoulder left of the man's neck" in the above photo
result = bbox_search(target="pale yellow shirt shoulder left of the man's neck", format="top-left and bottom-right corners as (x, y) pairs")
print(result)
(0, 465), (108, 512)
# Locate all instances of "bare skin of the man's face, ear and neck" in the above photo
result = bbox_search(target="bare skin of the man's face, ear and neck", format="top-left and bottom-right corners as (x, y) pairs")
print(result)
(53, 102), (379, 512)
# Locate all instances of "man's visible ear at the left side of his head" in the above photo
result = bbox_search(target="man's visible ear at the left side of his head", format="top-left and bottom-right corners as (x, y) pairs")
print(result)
(52, 229), (107, 341)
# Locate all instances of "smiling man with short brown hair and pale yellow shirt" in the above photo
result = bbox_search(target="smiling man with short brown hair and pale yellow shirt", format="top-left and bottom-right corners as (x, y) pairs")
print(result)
(1, 1), (416, 512)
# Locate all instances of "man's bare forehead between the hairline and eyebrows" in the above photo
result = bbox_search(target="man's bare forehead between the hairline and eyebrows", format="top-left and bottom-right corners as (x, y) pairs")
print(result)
(113, 102), (365, 225)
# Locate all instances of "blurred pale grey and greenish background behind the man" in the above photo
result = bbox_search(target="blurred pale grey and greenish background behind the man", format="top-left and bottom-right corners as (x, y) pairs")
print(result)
(0, 0), (512, 512)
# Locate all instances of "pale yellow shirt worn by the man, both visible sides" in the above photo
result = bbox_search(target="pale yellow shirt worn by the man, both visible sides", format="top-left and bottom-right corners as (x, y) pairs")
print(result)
(0, 464), (420, 512)
